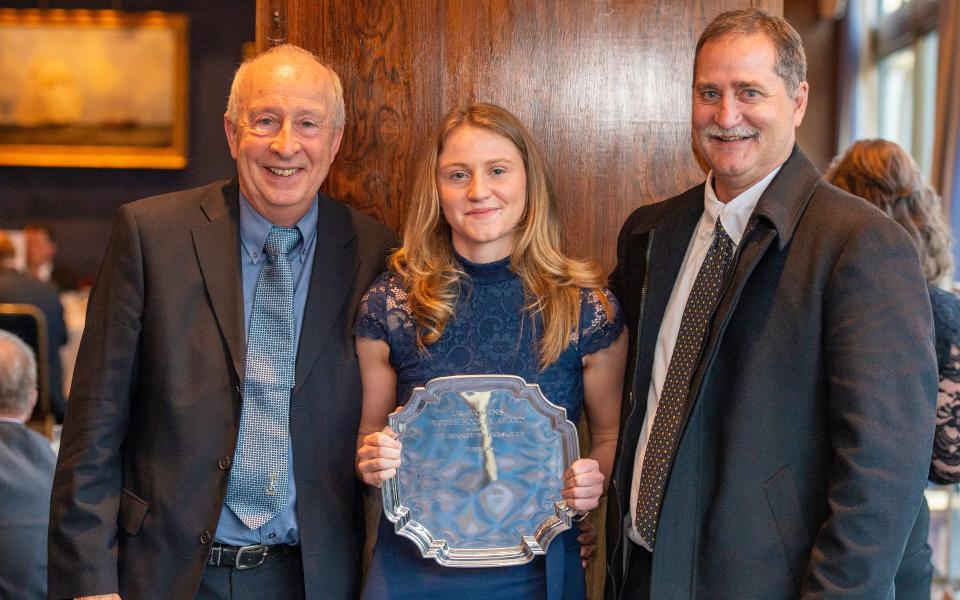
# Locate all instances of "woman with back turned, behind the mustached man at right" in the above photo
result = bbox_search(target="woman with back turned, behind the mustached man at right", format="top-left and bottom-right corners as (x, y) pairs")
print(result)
(824, 140), (960, 600)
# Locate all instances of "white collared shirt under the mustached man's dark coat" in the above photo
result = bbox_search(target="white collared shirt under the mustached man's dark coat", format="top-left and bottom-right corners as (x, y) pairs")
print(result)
(626, 167), (780, 550)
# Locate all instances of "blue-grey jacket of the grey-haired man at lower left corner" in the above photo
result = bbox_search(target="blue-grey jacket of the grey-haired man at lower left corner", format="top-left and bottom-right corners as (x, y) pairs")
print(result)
(0, 422), (57, 599)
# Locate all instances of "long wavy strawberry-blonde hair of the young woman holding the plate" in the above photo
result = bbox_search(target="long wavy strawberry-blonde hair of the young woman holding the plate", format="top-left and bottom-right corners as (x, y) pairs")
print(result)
(390, 103), (612, 369)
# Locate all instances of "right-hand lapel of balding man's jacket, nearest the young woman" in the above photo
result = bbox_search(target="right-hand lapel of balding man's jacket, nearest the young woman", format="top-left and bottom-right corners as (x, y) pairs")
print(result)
(293, 194), (359, 394)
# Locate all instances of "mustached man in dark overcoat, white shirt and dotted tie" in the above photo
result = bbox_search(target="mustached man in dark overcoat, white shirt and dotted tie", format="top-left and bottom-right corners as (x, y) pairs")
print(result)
(607, 10), (937, 600)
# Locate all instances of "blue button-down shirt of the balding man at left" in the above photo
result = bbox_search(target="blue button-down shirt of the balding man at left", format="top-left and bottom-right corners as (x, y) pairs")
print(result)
(215, 194), (318, 546)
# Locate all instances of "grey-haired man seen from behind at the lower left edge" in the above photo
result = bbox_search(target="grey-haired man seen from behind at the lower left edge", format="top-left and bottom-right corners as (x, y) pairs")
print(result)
(0, 330), (57, 598)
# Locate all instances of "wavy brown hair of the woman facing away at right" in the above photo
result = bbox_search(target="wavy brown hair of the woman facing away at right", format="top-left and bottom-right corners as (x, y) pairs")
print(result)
(824, 139), (953, 284)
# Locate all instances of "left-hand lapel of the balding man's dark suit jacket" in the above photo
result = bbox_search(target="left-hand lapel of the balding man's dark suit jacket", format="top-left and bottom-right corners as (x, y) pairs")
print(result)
(193, 180), (247, 379)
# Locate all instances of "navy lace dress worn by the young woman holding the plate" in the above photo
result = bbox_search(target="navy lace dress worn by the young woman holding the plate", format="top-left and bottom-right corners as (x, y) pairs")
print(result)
(354, 258), (623, 600)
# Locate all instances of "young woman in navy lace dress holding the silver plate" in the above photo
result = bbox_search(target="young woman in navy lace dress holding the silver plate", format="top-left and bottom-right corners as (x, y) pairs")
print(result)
(354, 104), (627, 600)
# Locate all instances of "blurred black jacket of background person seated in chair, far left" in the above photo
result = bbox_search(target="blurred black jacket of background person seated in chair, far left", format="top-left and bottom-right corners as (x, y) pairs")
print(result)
(0, 269), (67, 422)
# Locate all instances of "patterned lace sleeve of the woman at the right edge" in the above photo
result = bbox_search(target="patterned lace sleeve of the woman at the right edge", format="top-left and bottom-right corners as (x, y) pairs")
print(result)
(930, 345), (960, 483)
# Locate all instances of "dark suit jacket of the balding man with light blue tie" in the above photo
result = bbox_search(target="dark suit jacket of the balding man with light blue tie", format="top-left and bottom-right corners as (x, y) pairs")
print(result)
(50, 181), (395, 600)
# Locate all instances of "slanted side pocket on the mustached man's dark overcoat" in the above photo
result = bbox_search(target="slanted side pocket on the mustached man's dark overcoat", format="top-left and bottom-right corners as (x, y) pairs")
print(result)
(763, 467), (811, 590)
